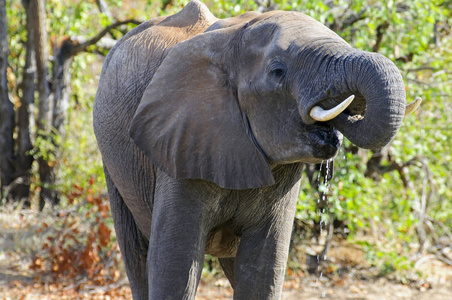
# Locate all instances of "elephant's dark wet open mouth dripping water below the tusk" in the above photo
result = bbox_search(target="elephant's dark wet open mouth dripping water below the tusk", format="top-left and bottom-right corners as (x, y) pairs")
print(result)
(309, 123), (342, 160)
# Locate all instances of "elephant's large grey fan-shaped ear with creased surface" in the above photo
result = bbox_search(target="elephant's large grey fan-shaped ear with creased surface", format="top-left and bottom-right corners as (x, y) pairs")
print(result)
(130, 28), (274, 189)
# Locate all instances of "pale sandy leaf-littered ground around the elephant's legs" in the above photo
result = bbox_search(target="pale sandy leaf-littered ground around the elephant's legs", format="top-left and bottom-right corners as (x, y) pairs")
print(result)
(0, 205), (452, 300)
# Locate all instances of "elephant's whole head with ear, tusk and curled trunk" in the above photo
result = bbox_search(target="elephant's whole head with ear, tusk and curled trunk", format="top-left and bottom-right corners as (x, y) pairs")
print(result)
(130, 11), (414, 189)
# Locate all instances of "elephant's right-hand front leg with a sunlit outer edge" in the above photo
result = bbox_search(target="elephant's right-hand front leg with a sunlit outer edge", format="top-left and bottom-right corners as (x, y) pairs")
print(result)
(234, 198), (296, 300)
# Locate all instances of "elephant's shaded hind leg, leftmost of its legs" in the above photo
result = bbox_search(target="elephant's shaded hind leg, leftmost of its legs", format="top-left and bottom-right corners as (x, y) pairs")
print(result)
(104, 168), (149, 299)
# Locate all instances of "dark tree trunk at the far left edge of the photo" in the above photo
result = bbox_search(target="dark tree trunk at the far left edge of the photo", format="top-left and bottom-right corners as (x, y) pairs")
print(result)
(0, 0), (14, 198)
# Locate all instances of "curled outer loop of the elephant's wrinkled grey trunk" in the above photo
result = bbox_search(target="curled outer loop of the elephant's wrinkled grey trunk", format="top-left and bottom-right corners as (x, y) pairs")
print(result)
(330, 51), (406, 149)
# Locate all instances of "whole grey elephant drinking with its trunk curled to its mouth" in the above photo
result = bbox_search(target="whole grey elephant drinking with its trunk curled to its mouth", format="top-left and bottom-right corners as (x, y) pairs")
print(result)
(94, 0), (420, 300)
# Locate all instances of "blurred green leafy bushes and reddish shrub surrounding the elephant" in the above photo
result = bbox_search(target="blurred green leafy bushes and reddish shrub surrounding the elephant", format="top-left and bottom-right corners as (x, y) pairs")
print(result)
(0, 0), (452, 292)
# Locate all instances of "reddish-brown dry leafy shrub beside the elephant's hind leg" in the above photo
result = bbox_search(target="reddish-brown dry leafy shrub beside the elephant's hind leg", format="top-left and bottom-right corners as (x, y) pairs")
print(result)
(30, 178), (120, 285)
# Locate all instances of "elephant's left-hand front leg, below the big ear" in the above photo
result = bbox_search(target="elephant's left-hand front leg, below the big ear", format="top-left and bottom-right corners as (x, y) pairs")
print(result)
(147, 179), (206, 300)
